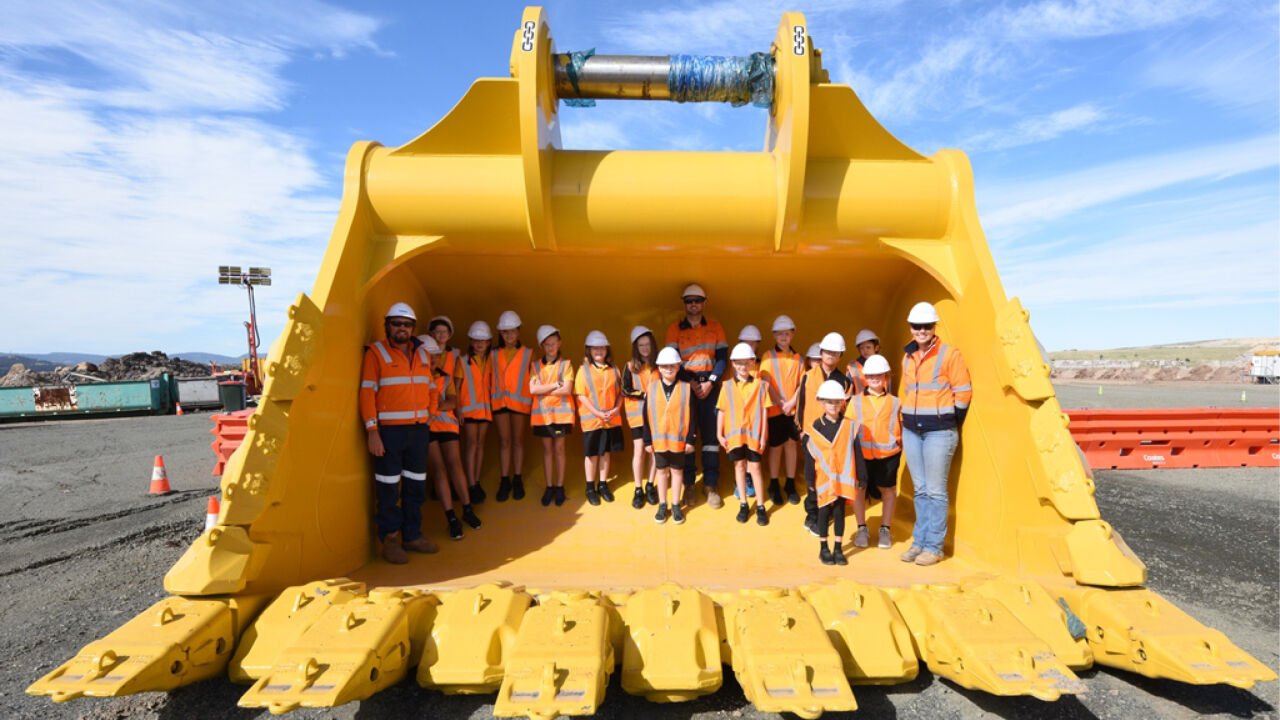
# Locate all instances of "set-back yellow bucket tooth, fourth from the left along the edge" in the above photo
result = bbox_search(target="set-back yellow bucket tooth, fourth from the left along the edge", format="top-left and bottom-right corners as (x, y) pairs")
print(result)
(417, 584), (532, 694)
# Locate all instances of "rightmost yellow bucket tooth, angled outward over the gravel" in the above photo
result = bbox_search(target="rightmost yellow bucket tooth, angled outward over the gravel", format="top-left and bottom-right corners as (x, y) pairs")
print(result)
(1064, 587), (1276, 689)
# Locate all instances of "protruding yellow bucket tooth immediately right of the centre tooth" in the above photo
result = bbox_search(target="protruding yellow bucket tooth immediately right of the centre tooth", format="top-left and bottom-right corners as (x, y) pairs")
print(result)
(724, 593), (858, 719)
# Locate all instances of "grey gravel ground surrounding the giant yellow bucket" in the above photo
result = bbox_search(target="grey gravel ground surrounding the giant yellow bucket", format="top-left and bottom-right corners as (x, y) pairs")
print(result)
(0, 384), (1280, 720)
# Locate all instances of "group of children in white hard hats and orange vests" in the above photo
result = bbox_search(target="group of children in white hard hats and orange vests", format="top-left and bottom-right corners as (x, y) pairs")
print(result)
(399, 310), (902, 565)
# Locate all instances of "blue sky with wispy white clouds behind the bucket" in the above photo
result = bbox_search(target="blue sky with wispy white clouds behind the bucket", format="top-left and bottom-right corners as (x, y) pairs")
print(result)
(0, 0), (1280, 354)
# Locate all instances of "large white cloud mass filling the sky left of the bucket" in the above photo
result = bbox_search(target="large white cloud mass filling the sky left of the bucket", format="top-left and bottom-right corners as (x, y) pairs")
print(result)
(0, 3), (378, 354)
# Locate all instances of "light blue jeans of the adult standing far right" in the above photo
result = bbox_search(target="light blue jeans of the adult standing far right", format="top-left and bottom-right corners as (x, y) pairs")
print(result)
(902, 428), (960, 555)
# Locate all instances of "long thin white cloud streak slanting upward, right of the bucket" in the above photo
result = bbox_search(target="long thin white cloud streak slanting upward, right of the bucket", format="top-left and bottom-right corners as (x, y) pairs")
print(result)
(978, 135), (1280, 236)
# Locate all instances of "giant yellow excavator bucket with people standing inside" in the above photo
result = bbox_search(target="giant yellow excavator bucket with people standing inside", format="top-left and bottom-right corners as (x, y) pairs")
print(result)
(28, 8), (1275, 717)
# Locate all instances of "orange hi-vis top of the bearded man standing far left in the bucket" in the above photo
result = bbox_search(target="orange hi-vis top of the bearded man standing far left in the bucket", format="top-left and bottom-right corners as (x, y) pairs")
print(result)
(360, 340), (433, 429)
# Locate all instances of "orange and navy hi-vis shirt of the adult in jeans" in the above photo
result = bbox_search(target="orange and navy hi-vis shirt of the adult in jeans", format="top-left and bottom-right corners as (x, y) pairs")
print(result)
(899, 340), (973, 432)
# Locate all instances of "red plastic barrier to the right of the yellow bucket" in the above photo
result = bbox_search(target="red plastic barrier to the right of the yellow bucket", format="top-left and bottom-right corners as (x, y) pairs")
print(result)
(1066, 407), (1280, 470)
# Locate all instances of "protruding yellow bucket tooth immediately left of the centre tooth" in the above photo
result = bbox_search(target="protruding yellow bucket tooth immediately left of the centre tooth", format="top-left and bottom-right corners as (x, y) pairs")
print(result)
(493, 593), (614, 720)
